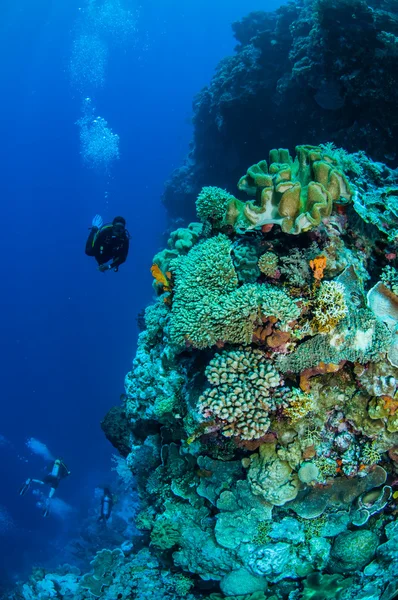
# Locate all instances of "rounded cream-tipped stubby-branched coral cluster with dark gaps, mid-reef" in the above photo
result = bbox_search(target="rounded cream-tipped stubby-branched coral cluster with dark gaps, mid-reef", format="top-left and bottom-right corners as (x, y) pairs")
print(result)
(199, 348), (282, 440)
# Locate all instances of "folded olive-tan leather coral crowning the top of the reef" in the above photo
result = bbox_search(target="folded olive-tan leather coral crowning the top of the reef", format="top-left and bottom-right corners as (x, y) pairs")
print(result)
(225, 146), (352, 235)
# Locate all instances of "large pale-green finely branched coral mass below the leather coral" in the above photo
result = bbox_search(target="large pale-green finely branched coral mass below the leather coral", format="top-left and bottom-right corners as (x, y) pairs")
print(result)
(170, 234), (300, 348)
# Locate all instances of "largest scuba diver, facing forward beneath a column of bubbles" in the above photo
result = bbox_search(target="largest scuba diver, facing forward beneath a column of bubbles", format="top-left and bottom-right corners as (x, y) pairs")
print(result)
(86, 215), (131, 273)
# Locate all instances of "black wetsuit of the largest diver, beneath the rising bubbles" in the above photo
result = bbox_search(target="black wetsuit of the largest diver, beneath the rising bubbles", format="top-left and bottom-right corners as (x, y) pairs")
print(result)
(86, 224), (130, 269)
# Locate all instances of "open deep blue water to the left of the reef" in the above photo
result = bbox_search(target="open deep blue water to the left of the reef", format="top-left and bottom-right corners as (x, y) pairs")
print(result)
(0, 0), (280, 583)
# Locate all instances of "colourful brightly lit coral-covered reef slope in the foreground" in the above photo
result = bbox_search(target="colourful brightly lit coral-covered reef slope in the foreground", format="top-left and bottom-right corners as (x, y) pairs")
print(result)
(14, 137), (398, 600)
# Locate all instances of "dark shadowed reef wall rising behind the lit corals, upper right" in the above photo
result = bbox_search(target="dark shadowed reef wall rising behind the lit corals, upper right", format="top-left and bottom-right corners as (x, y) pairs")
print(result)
(163, 0), (398, 220)
